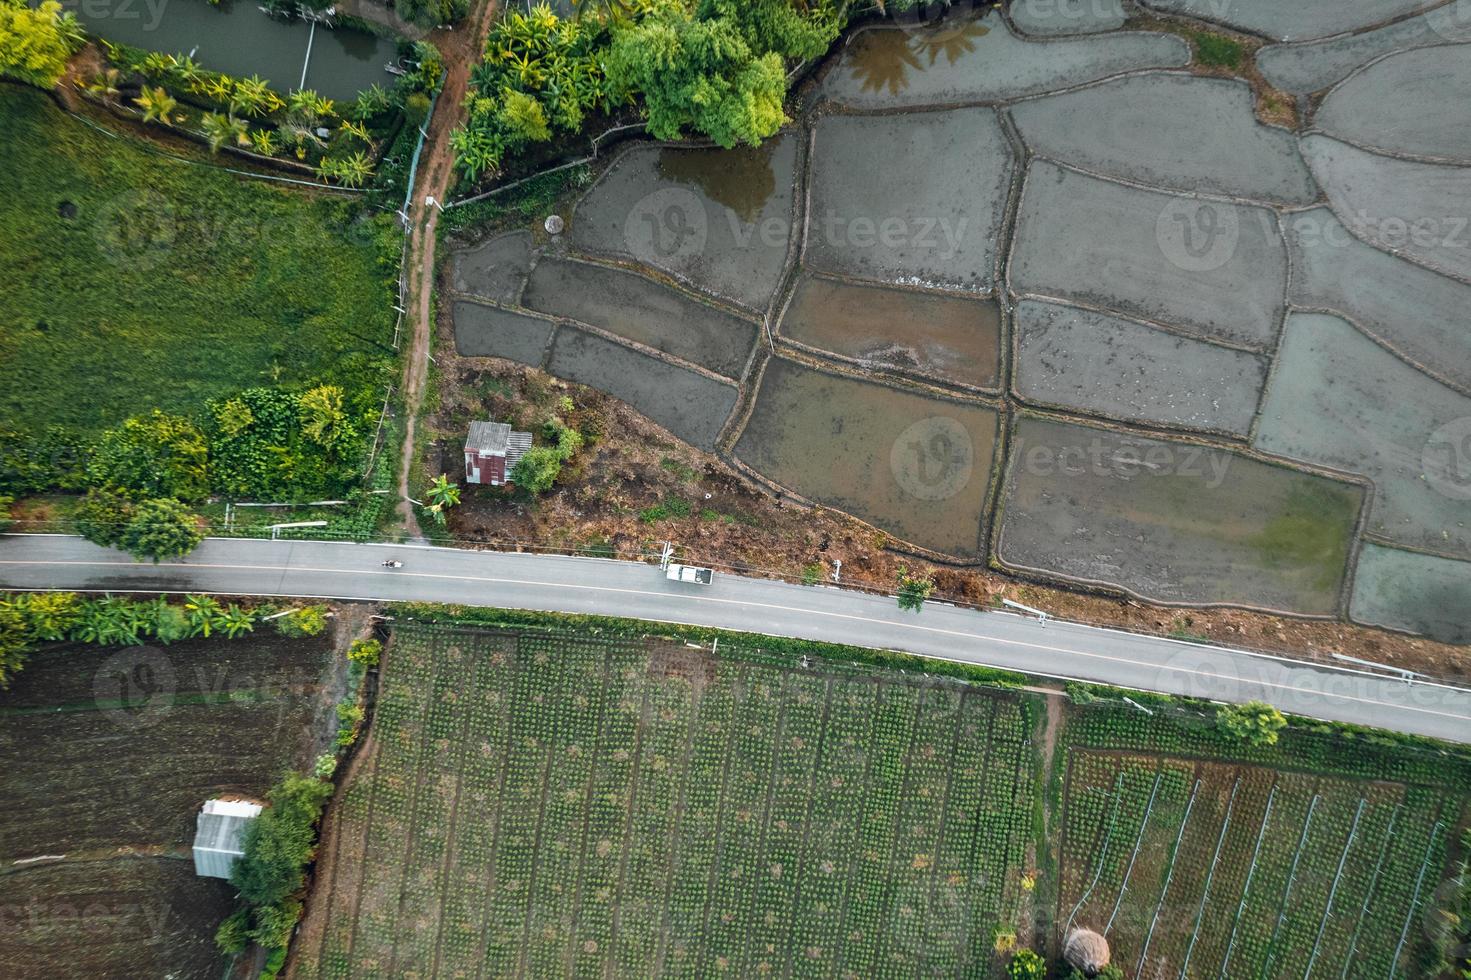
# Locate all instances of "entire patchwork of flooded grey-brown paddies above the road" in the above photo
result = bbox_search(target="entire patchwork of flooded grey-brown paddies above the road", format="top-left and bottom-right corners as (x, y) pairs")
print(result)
(443, 0), (1471, 642)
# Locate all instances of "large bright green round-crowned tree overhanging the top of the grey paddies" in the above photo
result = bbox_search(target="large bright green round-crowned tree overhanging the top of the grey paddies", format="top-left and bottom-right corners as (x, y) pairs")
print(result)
(608, 6), (787, 147)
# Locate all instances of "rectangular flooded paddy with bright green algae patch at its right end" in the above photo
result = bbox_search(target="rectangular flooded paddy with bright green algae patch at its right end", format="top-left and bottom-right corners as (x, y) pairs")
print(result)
(996, 418), (1362, 617)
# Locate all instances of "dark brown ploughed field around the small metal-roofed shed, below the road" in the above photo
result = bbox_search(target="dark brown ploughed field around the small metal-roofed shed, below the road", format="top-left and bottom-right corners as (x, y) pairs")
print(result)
(0, 634), (335, 977)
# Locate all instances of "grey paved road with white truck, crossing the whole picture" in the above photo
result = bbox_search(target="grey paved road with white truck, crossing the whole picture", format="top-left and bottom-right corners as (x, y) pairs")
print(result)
(0, 536), (1471, 743)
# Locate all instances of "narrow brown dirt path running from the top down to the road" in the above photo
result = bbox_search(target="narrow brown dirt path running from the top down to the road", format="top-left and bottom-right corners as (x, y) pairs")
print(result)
(399, 0), (499, 539)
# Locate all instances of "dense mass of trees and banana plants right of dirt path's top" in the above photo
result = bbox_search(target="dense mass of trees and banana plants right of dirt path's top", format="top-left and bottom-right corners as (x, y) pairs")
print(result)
(453, 0), (847, 181)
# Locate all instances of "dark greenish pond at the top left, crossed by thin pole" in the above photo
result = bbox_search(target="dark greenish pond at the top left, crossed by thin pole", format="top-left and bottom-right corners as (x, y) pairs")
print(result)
(63, 0), (399, 100)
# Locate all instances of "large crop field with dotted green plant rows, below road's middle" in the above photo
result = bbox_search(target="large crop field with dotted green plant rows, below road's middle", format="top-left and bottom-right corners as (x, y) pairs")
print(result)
(296, 628), (1040, 977)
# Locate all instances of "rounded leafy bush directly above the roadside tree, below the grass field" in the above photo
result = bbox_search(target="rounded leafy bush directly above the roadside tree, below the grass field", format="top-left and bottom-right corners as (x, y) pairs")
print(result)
(87, 409), (209, 502)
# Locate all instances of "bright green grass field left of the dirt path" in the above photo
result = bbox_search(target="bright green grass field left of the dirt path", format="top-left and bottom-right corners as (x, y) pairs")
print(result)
(0, 85), (397, 433)
